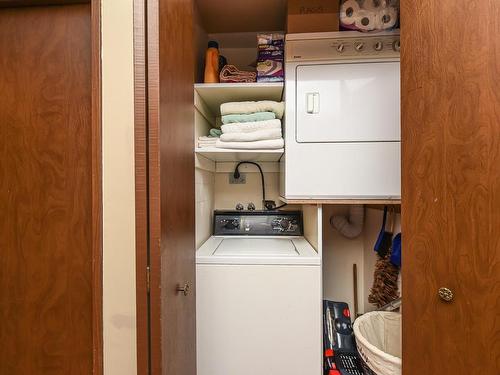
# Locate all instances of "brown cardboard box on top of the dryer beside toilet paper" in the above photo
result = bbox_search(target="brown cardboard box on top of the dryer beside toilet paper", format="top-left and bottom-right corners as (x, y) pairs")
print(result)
(287, 0), (339, 33)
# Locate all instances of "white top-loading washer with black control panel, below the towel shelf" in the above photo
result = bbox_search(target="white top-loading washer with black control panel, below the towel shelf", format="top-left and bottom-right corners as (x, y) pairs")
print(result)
(196, 211), (322, 375)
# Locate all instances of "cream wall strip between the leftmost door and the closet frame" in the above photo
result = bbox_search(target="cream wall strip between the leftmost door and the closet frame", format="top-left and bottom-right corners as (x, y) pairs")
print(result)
(102, 0), (137, 375)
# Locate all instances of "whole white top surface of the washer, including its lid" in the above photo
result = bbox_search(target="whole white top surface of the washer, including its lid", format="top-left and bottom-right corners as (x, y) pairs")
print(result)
(196, 236), (321, 265)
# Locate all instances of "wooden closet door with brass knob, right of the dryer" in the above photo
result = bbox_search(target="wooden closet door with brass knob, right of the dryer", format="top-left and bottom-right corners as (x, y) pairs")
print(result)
(401, 0), (500, 375)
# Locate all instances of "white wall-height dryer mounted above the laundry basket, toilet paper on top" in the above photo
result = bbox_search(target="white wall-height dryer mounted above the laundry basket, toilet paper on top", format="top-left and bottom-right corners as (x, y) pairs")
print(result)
(281, 32), (401, 199)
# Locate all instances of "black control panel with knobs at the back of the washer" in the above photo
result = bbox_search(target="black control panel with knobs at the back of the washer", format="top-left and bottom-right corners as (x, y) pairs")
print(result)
(214, 211), (303, 236)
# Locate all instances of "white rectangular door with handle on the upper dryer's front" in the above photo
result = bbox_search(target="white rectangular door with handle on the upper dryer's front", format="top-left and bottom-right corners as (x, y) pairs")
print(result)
(296, 62), (401, 143)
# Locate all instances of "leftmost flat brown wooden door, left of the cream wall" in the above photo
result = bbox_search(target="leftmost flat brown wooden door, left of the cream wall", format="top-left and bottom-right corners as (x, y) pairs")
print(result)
(0, 1), (101, 375)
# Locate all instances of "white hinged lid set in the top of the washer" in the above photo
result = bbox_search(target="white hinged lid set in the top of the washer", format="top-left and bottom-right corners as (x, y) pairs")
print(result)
(213, 238), (299, 258)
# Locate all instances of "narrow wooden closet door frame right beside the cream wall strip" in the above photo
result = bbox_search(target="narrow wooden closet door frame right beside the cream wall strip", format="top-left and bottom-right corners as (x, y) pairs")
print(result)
(134, 0), (162, 375)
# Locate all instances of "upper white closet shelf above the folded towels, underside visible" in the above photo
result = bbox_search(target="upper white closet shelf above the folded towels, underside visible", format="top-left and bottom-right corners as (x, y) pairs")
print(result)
(194, 82), (284, 115)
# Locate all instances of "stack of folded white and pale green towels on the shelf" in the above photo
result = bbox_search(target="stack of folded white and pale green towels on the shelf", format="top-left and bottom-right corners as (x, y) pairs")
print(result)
(215, 100), (285, 150)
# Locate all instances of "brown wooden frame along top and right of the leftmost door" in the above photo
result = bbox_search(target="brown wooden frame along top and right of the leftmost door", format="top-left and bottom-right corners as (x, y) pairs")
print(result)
(0, 0), (103, 375)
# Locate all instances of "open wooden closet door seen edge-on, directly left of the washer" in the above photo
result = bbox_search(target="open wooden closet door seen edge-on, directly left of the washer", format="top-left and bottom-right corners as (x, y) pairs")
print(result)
(147, 0), (196, 375)
